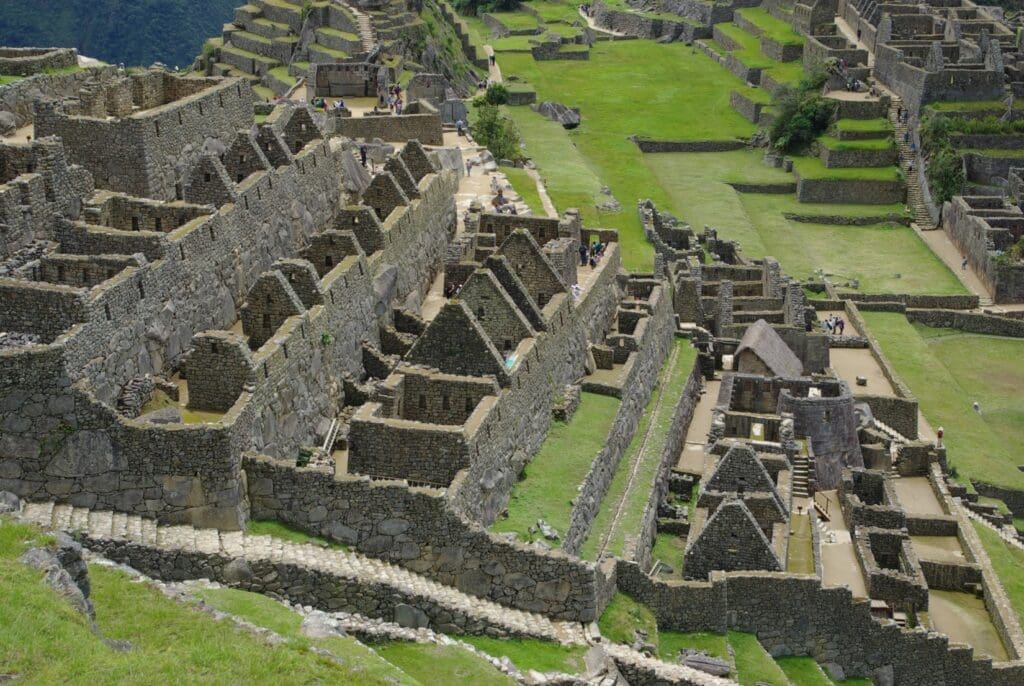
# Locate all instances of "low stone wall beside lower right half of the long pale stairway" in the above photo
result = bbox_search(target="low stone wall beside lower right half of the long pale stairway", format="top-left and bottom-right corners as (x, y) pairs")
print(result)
(244, 456), (603, 621)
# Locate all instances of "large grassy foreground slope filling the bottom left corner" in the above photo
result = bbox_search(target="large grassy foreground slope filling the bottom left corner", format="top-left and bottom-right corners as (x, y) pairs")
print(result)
(0, 521), (407, 685)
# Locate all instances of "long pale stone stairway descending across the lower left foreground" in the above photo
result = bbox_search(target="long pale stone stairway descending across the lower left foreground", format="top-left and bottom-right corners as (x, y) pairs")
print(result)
(22, 503), (586, 644)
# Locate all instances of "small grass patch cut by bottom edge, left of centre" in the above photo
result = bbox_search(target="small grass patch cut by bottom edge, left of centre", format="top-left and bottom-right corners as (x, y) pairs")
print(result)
(376, 643), (516, 686)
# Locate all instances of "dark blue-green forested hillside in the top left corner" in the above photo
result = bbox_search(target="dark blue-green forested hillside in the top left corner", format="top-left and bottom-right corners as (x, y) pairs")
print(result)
(0, 0), (235, 69)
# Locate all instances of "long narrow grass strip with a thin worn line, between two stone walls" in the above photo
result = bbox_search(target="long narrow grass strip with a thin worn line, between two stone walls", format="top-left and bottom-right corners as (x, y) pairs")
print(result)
(580, 339), (696, 560)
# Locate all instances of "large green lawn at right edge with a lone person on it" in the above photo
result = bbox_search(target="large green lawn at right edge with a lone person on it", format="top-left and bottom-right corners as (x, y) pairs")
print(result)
(863, 312), (1024, 488)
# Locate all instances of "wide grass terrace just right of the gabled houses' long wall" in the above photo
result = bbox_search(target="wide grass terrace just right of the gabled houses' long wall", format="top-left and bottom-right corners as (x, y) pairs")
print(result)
(492, 393), (620, 541)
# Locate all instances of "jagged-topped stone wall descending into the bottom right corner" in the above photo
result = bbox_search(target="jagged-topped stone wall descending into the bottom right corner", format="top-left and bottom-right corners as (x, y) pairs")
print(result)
(616, 562), (1024, 686)
